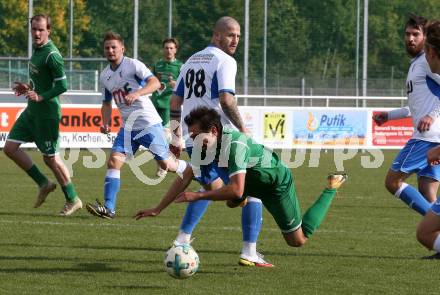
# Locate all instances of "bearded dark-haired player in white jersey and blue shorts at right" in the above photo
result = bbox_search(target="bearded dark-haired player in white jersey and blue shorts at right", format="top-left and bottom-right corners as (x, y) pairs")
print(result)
(373, 16), (440, 215)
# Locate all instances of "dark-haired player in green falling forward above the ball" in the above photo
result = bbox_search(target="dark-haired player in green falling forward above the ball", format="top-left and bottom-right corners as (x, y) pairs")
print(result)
(135, 107), (347, 247)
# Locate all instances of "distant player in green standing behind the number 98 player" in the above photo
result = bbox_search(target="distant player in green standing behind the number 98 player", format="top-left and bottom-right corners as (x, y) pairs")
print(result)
(151, 38), (183, 177)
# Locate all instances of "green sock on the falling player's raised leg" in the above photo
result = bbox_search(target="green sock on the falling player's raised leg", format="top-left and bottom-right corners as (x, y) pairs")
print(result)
(301, 188), (336, 238)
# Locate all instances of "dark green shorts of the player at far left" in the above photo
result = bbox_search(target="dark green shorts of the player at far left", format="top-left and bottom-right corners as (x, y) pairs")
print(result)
(8, 110), (60, 156)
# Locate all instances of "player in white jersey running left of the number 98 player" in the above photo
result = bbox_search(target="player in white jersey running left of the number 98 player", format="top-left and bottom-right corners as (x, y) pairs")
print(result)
(86, 32), (186, 219)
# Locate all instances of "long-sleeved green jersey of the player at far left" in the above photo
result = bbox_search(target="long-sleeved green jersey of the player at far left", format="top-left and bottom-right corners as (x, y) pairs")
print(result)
(27, 40), (67, 119)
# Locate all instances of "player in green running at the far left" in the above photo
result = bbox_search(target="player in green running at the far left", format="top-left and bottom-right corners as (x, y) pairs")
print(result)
(4, 14), (82, 216)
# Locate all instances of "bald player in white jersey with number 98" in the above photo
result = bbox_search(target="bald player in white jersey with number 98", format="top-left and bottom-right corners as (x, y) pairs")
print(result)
(166, 17), (273, 267)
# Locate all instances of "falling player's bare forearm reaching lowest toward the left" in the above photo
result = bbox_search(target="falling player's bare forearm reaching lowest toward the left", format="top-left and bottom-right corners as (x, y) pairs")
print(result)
(133, 165), (194, 220)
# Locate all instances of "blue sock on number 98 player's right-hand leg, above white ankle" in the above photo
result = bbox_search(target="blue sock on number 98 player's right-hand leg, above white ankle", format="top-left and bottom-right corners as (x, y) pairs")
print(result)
(241, 197), (263, 243)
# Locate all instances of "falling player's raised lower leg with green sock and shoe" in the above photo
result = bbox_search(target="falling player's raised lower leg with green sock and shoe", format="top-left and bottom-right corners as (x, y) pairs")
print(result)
(301, 173), (347, 238)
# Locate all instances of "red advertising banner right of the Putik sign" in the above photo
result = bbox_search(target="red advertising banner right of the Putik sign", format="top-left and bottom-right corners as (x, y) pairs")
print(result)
(372, 112), (414, 147)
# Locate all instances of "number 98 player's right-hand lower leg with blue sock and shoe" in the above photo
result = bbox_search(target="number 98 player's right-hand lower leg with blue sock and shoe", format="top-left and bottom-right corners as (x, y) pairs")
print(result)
(238, 197), (273, 267)
